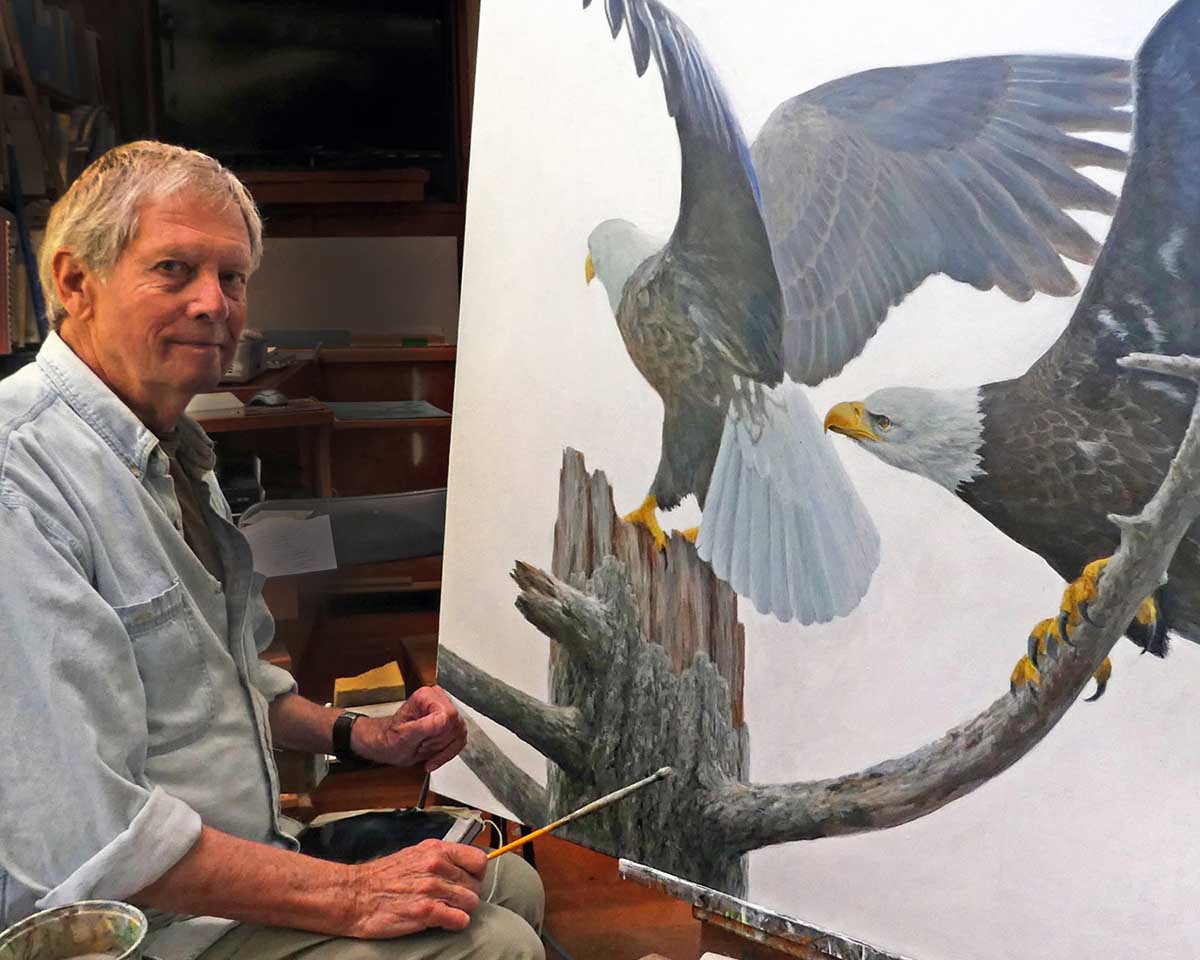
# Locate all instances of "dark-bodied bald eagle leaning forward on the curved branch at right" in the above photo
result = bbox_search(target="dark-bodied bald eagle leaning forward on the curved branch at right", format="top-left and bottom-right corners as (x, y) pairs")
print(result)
(826, 0), (1200, 656)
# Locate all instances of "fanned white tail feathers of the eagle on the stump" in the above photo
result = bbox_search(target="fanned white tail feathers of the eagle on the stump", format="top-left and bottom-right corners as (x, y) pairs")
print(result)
(696, 380), (880, 624)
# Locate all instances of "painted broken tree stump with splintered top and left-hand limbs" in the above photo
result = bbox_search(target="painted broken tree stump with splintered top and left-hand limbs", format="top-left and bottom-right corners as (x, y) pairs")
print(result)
(439, 450), (749, 892)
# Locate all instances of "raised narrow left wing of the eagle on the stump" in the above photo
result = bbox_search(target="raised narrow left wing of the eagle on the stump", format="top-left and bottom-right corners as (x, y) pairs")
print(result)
(583, 0), (782, 384)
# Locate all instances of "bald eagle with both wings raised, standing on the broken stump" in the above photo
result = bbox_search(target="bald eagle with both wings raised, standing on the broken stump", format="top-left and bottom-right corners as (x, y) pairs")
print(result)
(583, 0), (1129, 623)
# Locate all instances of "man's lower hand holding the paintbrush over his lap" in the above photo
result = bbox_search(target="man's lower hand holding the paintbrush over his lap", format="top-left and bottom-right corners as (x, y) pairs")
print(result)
(348, 840), (487, 940)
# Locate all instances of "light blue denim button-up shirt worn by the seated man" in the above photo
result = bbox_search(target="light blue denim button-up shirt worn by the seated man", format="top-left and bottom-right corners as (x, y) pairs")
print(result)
(0, 334), (295, 955)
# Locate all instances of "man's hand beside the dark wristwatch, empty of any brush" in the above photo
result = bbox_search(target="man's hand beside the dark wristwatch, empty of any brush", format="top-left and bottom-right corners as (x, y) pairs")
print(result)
(350, 686), (467, 770)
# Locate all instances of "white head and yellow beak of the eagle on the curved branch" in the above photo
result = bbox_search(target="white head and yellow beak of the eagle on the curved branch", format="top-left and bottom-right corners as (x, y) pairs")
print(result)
(824, 386), (984, 493)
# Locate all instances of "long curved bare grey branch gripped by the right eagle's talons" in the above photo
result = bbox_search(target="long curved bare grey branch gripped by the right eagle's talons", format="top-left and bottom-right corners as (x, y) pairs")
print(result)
(706, 356), (1200, 851)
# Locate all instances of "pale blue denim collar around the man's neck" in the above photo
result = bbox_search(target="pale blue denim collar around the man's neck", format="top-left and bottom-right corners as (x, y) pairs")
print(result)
(37, 331), (216, 476)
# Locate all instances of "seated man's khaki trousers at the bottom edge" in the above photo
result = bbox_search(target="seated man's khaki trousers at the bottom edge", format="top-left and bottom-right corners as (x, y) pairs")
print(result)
(199, 853), (546, 960)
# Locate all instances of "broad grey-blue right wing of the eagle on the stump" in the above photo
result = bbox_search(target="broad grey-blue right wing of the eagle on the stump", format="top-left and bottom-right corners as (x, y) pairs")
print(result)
(752, 56), (1130, 384)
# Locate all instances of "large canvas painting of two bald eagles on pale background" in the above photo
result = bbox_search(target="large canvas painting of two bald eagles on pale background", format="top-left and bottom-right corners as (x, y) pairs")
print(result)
(434, 0), (1200, 960)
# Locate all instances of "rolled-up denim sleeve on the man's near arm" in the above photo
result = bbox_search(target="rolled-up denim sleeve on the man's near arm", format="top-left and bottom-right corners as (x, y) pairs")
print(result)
(0, 500), (200, 907)
